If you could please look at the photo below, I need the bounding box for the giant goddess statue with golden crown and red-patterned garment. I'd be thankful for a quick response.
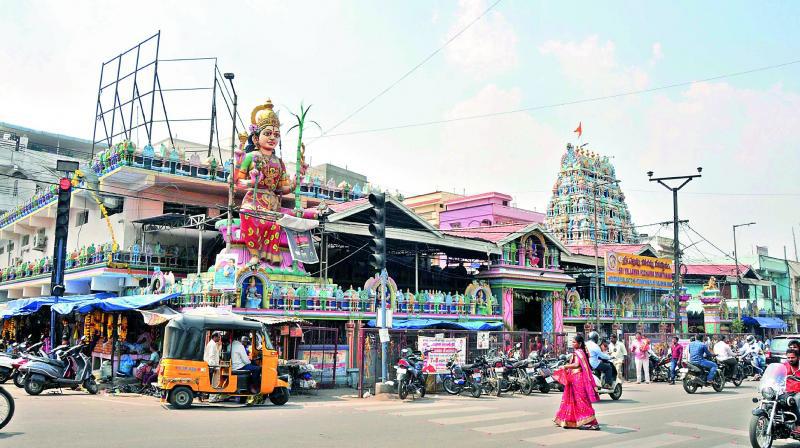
[235,99,306,266]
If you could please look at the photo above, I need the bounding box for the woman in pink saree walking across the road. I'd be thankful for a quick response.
[553,335,600,430]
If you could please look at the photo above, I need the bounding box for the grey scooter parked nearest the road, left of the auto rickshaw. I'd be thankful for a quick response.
[25,344,98,395]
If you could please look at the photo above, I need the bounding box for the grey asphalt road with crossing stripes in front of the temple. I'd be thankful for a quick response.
[0,382,788,448]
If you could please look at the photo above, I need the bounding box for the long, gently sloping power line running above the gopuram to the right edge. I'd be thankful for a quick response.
[317,59,800,139]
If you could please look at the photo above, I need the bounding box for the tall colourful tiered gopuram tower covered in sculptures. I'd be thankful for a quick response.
[545,144,637,244]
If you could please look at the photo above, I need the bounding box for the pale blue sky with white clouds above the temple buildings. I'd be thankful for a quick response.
[0,0,800,263]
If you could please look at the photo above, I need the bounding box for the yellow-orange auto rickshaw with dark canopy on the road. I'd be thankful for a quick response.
[157,314,289,409]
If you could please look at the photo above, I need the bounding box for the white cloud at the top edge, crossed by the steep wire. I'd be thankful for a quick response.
[445,0,519,79]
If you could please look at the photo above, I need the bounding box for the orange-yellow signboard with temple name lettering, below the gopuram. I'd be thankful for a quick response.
[605,252,673,290]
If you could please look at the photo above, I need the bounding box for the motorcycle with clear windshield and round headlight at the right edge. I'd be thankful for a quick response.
[749,363,800,448]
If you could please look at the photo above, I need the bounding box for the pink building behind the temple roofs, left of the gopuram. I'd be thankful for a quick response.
[439,192,545,230]
